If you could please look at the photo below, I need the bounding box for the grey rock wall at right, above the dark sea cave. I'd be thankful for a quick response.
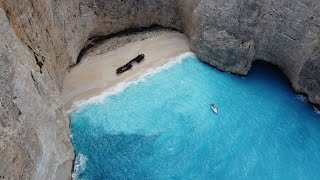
[192,0,320,105]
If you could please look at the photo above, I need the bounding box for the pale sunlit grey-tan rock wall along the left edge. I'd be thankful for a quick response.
[0,1,74,179]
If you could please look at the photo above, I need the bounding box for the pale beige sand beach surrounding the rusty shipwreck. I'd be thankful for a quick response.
[61,31,190,110]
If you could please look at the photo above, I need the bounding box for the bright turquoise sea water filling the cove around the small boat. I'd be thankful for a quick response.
[70,56,320,179]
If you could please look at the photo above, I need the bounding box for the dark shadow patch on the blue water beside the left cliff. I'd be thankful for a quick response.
[74,132,157,179]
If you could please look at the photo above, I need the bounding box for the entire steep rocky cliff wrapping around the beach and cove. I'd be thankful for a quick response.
[0,0,320,179]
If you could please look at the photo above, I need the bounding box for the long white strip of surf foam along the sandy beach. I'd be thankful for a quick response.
[68,52,196,113]
